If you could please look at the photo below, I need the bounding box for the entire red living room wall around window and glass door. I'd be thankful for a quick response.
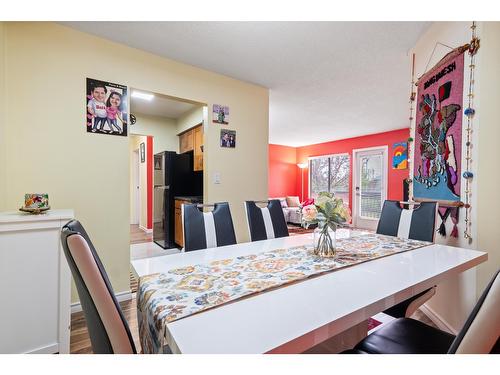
[269,128,410,206]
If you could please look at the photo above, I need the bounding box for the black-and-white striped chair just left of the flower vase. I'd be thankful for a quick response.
[245,199,288,241]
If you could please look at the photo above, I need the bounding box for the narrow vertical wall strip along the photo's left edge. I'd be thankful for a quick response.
[0,22,7,211]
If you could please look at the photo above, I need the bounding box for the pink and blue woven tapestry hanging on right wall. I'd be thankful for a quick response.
[413,51,464,202]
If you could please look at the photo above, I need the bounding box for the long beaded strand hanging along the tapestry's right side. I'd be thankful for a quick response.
[462,22,479,242]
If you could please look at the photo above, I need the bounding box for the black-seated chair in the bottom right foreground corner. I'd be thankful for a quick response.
[344,271,500,354]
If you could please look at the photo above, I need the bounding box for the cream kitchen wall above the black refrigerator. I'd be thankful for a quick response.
[129,112,179,154]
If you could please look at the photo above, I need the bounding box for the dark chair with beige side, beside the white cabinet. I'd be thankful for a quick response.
[61,220,137,354]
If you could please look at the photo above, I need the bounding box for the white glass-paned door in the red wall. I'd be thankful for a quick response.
[353,147,387,230]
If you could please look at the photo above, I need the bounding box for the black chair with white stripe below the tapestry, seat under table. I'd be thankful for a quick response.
[377,200,437,318]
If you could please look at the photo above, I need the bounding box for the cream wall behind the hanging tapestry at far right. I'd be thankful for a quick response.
[410,22,500,332]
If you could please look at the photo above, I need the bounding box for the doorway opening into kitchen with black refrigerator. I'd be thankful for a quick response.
[129,88,208,259]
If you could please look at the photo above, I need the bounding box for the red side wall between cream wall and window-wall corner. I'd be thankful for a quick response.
[268,145,300,198]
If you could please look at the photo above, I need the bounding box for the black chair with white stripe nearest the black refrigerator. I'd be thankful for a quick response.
[182,202,236,251]
